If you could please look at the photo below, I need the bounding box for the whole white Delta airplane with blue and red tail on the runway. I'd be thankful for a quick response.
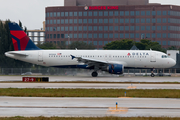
[5,23,176,77]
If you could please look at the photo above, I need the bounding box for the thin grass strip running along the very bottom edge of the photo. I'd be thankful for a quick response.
[0,116,180,120]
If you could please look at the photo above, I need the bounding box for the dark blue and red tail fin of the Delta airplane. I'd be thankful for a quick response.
[9,23,40,51]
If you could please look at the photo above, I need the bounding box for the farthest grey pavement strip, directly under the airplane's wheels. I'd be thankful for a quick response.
[0,76,180,82]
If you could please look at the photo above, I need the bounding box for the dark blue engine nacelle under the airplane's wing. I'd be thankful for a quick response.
[107,64,124,74]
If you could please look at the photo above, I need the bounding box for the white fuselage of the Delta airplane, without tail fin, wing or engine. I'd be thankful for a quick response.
[5,50,176,68]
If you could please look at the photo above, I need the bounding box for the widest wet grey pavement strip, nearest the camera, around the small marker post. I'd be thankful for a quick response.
[0,97,180,117]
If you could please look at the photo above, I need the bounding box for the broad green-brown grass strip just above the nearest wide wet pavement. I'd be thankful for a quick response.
[0,88,180,98]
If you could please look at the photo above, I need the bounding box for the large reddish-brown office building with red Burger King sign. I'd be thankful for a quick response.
[45,0,180,49]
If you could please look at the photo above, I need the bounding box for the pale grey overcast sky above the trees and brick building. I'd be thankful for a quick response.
[0,0,180,30]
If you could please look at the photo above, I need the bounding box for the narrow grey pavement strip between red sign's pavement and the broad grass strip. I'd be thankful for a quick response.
[0,83,180,89]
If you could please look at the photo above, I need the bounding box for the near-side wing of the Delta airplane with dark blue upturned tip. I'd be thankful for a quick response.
[71,55,127,67]
